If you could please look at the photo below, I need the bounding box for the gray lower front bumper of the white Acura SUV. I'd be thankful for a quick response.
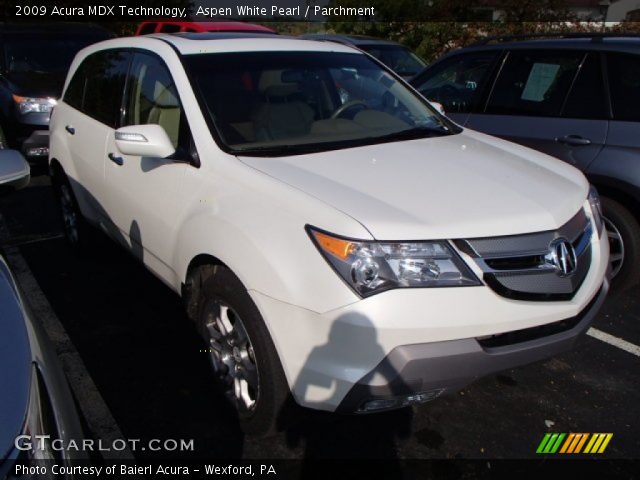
[337,280,609,413]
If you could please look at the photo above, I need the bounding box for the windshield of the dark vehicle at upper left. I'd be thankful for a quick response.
[3,36,105,73]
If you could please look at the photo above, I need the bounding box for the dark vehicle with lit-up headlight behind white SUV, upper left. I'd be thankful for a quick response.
[0,23,113,159]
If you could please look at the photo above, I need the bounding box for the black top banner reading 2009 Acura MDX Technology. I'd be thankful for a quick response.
[0,0,640,24]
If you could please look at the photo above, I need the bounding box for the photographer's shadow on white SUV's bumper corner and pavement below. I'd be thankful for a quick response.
[279,313,413,478]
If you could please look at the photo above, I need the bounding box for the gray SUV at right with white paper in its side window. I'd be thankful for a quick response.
[411,35,640,290]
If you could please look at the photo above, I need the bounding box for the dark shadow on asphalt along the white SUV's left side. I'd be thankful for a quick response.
[12,175,244,460]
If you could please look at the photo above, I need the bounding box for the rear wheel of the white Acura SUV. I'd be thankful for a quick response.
[52,172,96,253]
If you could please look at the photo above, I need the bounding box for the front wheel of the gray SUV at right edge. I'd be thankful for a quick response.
[601,197,640,293]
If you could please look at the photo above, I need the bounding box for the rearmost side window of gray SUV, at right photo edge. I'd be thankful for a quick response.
[607,53,640,122]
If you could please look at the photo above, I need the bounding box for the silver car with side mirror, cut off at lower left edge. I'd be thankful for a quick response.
[0,149,86,479]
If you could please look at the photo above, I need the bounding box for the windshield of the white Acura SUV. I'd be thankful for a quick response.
[186,52,456,156]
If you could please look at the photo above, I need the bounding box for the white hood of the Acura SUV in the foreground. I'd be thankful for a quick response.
[240,130,589,240]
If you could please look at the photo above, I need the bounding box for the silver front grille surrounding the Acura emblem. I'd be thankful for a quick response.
[455,209,593,301]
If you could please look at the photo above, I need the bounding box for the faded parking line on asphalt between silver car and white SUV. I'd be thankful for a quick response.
[0,214,134,460]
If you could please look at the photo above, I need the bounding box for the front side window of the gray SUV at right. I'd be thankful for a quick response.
[412,52,497,113]
